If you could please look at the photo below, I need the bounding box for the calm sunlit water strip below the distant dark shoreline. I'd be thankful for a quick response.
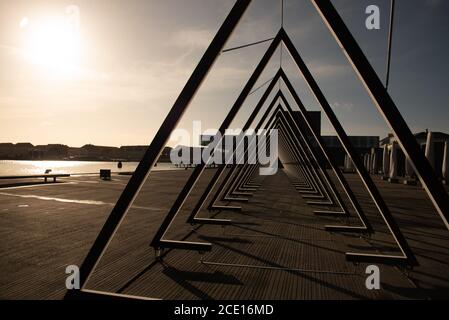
[0,160,179,176]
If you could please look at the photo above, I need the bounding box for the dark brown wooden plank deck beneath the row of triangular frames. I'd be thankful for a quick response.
[0,169,449,299]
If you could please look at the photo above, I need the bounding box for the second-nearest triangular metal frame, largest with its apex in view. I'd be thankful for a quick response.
[151,27,417,266]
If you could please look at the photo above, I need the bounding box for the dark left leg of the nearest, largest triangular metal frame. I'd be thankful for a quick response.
[65,0,251,299]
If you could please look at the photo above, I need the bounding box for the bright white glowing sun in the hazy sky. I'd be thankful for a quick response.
[25,18,83,72]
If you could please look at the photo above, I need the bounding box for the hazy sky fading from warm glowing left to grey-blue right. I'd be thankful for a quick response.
[0,0,449,147]
